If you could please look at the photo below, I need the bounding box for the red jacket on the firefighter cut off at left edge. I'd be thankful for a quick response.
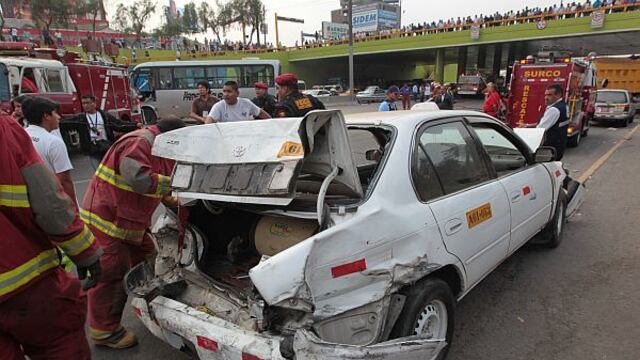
[0,116,101,303]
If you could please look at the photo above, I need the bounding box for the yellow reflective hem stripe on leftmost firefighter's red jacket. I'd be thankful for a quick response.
[0,249,60,296]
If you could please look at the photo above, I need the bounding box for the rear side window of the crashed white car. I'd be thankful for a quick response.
[414,121,491,201]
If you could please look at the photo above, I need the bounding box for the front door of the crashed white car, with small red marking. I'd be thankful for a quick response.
[469,118,553,253]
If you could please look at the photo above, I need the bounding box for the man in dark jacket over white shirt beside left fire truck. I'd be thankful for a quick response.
[74,94,140,161]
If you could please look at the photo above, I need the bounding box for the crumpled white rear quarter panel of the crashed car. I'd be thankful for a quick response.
[250,126,464,319]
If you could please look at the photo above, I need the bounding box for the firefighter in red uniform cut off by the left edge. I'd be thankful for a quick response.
[0,116,101,360]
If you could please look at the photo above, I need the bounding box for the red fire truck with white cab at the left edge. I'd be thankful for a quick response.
[0,42,143,151]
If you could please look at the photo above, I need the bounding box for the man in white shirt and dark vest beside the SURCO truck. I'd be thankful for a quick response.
[537,84,569,161]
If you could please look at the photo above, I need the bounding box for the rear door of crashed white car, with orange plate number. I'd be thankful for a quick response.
[412,118,510,286]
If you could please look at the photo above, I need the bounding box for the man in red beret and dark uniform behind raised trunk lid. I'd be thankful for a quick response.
[275,73,325,117]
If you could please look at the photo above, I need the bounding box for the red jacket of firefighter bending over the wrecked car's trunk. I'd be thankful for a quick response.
[80,126,174,244]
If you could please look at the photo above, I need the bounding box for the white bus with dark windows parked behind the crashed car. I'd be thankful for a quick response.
[131,60,280,123]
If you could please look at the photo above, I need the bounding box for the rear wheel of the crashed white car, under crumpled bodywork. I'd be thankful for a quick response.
[390,277,455,360]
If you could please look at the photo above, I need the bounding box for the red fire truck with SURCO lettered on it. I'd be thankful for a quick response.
[506,51,596,147]
